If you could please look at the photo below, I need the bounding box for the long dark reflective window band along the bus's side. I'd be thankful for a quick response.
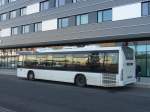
[19,51,119,73]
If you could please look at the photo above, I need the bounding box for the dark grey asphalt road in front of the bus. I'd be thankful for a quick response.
[0,75,150,112]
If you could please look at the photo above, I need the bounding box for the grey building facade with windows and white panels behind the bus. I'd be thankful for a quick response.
[0,0,150,77]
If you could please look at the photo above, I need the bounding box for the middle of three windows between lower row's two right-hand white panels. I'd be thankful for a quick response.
[76,14,88,25]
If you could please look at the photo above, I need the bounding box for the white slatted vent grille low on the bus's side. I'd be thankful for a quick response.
[102,73,116,87]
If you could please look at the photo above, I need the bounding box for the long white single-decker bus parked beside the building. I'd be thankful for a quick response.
[17,47,136,87]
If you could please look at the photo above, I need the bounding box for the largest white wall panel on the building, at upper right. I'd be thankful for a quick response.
[112,3,141,21]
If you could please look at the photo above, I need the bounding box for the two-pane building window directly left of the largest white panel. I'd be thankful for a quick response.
[98,9,112,23]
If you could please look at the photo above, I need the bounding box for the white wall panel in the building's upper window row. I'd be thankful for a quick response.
[27,3,40,15]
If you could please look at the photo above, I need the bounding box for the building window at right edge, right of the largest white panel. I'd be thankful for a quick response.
[142,2,150,16]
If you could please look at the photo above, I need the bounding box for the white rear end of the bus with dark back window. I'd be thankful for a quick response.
[120,47,136,85]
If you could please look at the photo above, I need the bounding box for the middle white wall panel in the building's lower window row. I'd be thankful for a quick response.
[42,19,57,31]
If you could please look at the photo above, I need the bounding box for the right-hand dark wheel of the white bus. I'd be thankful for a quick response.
[75,74,86,87]
